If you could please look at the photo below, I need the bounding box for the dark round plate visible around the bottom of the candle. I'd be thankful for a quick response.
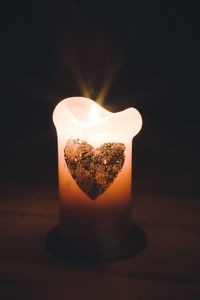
[45,223,146,262]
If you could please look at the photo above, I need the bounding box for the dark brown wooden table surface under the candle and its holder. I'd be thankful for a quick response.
[0,184,200,300]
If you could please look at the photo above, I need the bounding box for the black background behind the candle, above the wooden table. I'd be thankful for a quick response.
[0,0,200,195]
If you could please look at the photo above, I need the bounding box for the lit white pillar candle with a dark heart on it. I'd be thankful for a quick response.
[53,97,142,257]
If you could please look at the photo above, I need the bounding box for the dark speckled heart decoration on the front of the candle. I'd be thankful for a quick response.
[64,139,125,200]
